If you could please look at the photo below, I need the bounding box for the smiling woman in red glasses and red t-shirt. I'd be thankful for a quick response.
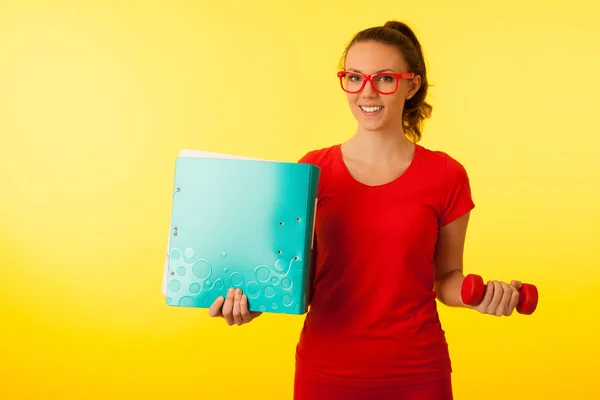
[210,21,521,400]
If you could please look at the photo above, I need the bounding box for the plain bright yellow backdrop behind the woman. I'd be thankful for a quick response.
[0,0,600,400]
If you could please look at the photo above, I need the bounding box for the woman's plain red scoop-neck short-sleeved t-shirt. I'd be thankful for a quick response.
[296,145,474,387]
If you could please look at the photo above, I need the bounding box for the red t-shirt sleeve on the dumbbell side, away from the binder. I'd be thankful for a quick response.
[440,156,475,227]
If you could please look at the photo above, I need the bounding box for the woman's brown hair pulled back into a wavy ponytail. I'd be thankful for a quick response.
[340,21,432,142]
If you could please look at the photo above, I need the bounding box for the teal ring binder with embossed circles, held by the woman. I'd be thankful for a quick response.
[163,151,320,314]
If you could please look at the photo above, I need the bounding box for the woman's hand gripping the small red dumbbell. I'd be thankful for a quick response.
[470,281,523,317]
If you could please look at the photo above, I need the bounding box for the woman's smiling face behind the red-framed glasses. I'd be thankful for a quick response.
[345,42,420,131]
